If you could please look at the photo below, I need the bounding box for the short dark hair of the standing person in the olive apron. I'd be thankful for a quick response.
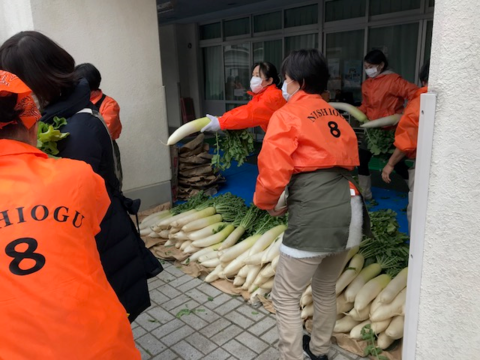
[282,49,329,95]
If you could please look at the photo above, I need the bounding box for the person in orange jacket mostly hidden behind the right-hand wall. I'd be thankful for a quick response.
[382,61,430,232]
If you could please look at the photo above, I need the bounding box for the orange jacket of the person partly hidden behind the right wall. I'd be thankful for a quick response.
[393,86,428,159]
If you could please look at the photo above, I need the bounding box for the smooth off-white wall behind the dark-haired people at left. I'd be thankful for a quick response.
[2,0,171,207]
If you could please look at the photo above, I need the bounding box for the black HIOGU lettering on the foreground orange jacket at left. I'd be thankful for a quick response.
[0,205,85,229]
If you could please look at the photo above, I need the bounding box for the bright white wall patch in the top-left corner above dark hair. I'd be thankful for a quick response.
[0,0,33,44]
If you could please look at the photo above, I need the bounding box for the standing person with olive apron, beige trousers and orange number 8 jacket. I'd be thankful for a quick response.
[254,50,368,360]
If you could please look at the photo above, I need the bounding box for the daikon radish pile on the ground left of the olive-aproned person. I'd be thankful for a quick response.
[140,194,287,303]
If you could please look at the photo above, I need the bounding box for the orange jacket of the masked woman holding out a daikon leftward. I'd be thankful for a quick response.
[218,85,286,131]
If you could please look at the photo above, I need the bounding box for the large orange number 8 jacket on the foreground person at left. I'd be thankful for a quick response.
[0,140,140,360]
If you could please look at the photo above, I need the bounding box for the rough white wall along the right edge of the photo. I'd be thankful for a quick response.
[414,0,480,360]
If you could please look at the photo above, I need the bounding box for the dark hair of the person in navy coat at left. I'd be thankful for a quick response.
[0,31,77,107]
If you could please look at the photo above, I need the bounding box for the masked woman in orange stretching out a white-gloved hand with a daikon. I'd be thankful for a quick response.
[201,61,285,132]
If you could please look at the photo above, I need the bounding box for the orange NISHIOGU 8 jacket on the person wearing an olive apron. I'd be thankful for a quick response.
[254,91,359,210]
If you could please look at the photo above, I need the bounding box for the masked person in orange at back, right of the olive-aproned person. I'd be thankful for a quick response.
[358,50,418,200]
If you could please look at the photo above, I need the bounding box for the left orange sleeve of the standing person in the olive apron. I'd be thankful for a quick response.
[253,113,298,210]
